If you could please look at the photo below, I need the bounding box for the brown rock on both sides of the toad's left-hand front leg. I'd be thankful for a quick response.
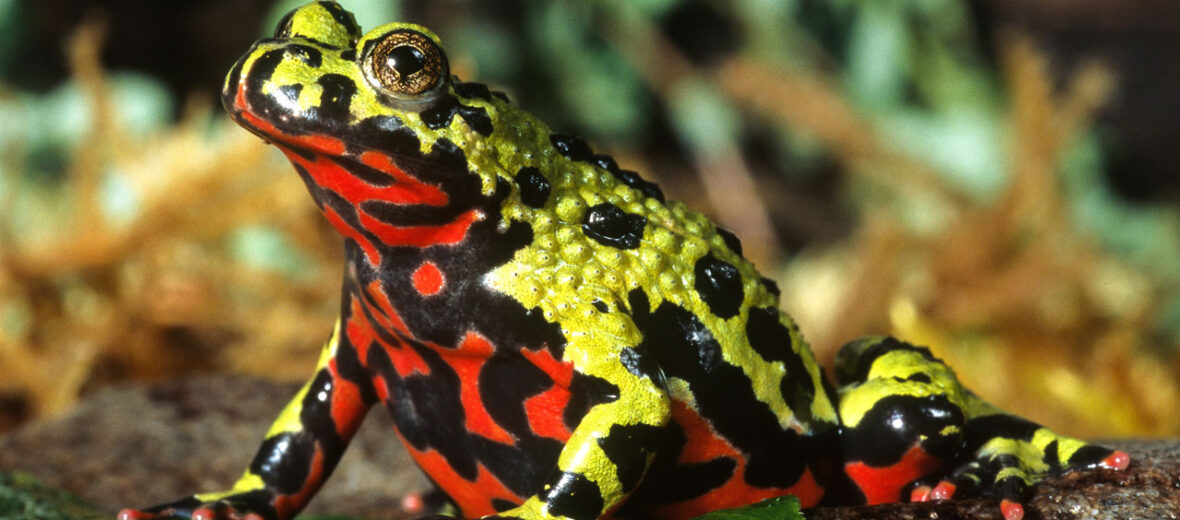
[0,375,428,519]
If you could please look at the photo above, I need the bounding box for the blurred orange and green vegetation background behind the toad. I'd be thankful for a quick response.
[0,0,1180,437]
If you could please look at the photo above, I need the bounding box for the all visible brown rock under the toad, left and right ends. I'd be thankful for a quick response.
[0,375,1180,520]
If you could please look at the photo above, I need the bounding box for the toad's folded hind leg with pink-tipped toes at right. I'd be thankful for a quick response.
[835,337,1129,520]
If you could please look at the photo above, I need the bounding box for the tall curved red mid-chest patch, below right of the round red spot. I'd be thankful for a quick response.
[445,331,516,445]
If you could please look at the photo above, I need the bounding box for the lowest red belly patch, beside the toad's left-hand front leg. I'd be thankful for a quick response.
[402,439,524,518]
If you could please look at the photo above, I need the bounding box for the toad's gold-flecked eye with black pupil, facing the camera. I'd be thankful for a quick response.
[363,29,447,99]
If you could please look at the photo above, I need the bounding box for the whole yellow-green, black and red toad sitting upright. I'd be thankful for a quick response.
[120,2,1126,520]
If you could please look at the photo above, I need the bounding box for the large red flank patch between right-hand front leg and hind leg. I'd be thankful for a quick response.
[654,401,824,519]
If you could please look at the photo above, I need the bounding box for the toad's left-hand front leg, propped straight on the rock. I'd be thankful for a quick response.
[118,323,375,520]
